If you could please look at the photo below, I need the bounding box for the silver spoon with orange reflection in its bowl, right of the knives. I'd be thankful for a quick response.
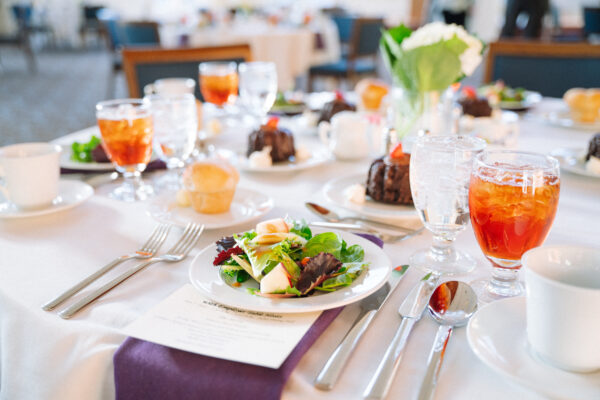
[418,281,477,400]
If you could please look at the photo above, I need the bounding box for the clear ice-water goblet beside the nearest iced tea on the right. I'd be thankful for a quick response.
[410,136,485,274]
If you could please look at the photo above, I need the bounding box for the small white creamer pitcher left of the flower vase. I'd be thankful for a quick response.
[319,111,370,160]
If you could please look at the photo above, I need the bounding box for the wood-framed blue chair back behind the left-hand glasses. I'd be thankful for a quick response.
[123,44,252,99]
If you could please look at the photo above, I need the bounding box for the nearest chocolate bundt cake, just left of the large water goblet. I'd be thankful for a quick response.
[367,154,413,205]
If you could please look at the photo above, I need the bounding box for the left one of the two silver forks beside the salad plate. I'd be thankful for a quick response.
[42,224,171,311]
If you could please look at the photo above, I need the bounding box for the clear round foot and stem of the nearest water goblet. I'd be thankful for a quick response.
[409,236,477,275]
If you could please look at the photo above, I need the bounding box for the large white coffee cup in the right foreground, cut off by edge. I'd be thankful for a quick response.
[522,246,600,372]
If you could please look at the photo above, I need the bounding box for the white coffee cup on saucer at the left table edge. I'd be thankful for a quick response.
[0,143,61,209]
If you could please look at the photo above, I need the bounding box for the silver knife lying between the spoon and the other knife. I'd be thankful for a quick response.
[364,273,440,399]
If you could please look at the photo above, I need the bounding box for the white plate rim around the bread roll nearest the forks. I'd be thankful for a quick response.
[146,187,275,230]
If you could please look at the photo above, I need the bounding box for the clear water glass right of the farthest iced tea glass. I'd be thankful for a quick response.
[239,62,277,122]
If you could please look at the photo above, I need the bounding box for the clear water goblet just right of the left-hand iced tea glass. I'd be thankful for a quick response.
[144,93,198,190]
